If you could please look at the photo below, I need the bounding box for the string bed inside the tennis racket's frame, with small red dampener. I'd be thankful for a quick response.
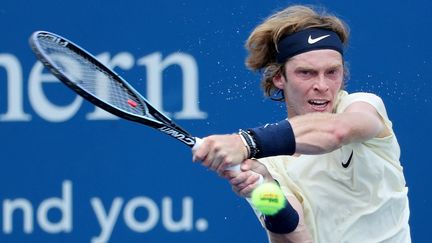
[34,38,149,116]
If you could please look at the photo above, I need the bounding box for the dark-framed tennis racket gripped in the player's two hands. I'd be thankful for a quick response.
[29,31,250,175]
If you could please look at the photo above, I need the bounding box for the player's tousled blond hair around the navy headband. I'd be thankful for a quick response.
[245,5,349,97]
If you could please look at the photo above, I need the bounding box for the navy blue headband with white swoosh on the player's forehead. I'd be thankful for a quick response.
[276,28,343,64]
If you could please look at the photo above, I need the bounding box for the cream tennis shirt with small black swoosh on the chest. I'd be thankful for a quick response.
[258,91,411,243]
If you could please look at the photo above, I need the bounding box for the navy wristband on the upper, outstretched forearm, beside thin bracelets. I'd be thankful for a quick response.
[248,120,296,159]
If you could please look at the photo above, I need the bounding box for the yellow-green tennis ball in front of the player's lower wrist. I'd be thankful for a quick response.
[252,183,286,216]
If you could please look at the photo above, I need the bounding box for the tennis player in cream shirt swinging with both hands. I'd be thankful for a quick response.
[193,5,411,243]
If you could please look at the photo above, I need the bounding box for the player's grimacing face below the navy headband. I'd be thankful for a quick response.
[273,50,344,117]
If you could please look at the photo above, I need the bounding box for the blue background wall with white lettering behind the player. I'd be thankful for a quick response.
[0,0,432,242]
